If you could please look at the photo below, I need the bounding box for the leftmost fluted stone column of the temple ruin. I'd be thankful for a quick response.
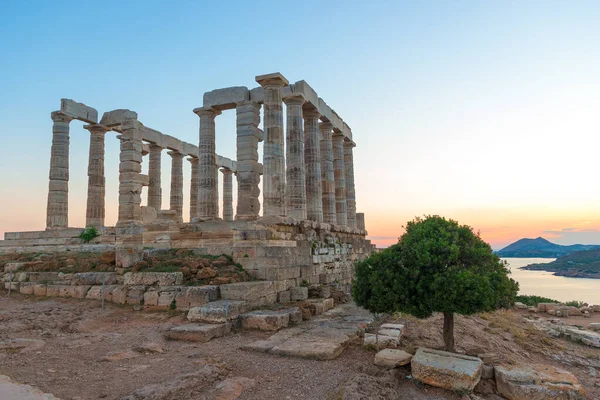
[46,111,72,229]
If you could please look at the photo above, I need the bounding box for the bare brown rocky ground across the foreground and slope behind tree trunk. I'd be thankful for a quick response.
[0,291,600,400]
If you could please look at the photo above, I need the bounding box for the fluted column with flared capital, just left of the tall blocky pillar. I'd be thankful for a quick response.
[194,107,221,220]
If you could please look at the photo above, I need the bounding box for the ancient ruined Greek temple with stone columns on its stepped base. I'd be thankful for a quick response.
[0,73,372,286]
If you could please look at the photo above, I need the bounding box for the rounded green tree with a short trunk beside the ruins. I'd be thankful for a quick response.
[352,216,519,351]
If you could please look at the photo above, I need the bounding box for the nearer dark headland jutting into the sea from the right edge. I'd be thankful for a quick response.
[521,248,600,279]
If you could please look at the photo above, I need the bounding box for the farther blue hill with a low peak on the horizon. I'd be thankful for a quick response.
[496,237,600,258]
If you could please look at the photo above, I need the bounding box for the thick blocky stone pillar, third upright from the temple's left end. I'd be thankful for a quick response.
[117,120,144,225]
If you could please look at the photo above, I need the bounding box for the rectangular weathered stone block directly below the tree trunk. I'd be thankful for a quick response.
[411,349,483,392]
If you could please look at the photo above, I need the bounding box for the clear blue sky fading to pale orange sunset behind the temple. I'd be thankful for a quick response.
[0,0,600,249]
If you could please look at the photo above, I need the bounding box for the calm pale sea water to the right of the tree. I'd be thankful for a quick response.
[503,258,600,304]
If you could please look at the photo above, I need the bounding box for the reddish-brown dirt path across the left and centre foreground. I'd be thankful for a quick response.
[0,292,457,400]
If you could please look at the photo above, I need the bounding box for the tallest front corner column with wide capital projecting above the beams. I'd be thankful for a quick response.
[256,73,289,216]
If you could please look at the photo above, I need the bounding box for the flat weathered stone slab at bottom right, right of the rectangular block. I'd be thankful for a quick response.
[494,365,586,400]
